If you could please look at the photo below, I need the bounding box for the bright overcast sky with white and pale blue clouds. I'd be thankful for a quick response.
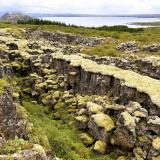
[0,0,160,14]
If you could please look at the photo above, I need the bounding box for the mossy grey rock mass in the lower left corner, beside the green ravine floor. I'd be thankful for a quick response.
[0,79,49,160]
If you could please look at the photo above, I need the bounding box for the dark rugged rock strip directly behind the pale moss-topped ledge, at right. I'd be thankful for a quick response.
[87,56,160,79]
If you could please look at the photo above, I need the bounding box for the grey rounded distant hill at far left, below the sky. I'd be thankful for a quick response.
[0,12,33,23]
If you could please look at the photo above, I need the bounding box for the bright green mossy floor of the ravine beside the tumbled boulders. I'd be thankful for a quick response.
[23,101,114,160]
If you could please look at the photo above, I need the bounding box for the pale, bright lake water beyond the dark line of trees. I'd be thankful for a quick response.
[42,17,160,28]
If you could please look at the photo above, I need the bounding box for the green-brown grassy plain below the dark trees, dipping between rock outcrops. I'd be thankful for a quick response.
[0,23,160,57]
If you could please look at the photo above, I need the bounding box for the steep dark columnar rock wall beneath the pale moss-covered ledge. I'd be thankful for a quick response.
[51,53,160,115]
